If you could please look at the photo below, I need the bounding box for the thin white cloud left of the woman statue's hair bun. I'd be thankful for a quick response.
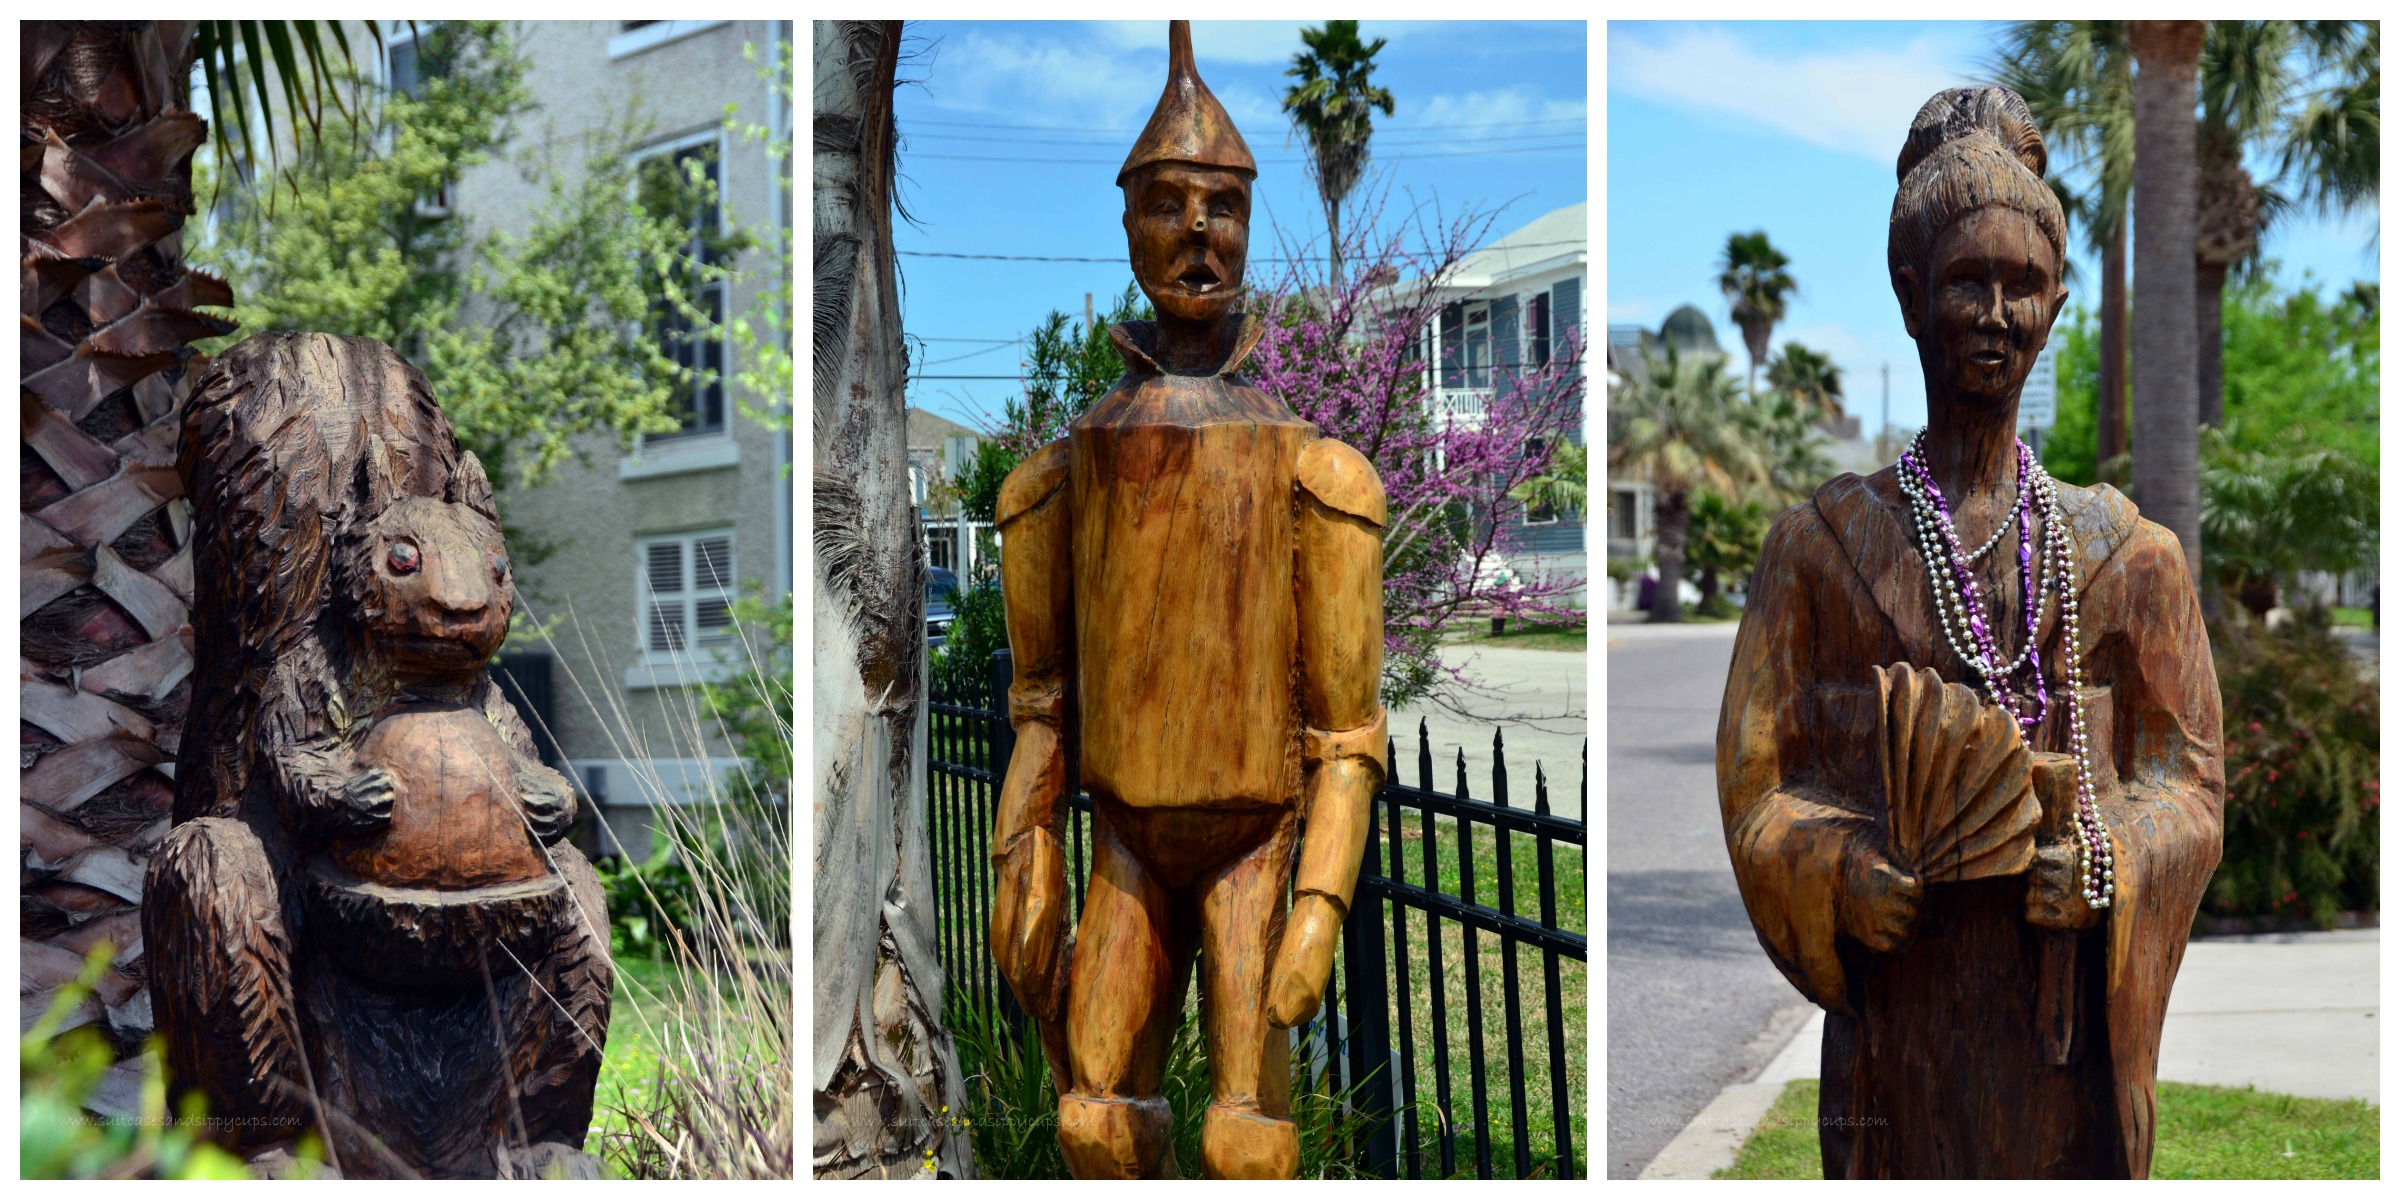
[1608,29,1966,163]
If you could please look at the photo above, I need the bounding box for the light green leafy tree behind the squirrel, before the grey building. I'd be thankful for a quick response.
[194,22,746,485]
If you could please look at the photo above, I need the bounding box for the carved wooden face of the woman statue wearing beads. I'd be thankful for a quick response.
[1891,206,2066,401]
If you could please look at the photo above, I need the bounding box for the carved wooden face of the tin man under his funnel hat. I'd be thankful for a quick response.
[1126,163,1250,322]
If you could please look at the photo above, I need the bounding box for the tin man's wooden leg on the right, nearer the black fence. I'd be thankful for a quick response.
[1198,816,1301,1178]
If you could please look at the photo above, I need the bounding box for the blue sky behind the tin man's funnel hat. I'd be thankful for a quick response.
[893,22,1591,425]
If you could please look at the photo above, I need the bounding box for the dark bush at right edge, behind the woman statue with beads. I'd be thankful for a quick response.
[2206,612,2383,929]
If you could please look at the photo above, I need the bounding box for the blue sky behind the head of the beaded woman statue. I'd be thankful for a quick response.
[1606,22,2381,430]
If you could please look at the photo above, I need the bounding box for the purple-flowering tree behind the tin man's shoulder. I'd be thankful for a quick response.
[1243,194,1584,706]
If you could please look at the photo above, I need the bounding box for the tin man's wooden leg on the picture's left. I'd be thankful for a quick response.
[1058,802,1193,1178]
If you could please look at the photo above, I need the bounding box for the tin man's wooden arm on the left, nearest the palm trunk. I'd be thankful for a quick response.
[991,439,1075,1022]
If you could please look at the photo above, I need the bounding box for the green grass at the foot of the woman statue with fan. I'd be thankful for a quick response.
[1714,1080,2383,1178]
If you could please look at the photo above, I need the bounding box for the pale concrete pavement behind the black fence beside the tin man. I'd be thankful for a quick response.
[1392,643,1591,818]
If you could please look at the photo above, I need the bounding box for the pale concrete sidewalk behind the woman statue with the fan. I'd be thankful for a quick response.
[1642,929,2383,1178]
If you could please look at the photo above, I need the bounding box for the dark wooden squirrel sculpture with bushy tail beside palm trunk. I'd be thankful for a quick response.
[142,334,612,1176]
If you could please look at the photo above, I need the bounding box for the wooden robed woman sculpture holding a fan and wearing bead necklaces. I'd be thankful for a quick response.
[1716,89,2225,1178]
